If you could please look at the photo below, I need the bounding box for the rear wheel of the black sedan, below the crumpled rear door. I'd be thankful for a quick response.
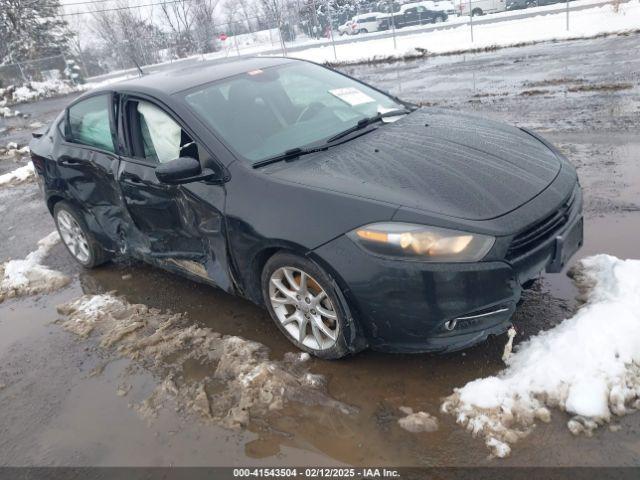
[53,201,110,269]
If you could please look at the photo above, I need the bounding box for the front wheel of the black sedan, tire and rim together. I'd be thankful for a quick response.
[261,252,363,360]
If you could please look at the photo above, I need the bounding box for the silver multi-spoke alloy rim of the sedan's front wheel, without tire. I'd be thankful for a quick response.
[269,267,340,350]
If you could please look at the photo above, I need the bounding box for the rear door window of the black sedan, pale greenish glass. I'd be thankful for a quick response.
[67,94,115,152]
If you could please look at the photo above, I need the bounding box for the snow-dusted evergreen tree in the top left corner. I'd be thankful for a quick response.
[0,0,73,64]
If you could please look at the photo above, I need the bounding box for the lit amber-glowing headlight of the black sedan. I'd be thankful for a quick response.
[347,222,495,262]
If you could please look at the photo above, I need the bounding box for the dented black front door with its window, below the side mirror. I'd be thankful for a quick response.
[118,96,231,290]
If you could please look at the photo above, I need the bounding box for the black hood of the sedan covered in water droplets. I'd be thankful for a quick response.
[270,109,561,220]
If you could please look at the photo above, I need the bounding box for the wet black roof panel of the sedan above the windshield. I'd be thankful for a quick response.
[91,57,295,95]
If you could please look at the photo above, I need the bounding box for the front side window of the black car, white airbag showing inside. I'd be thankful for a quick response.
[135,100,198,163]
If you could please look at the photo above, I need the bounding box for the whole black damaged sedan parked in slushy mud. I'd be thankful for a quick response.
[31,58,583,358]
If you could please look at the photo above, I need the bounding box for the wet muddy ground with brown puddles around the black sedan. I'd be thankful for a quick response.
[0,32,640,466]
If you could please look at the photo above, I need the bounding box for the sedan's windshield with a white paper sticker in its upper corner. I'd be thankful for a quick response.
[184,62,404,163]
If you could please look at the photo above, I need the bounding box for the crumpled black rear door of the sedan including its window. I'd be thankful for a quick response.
[50,92,123,250]
